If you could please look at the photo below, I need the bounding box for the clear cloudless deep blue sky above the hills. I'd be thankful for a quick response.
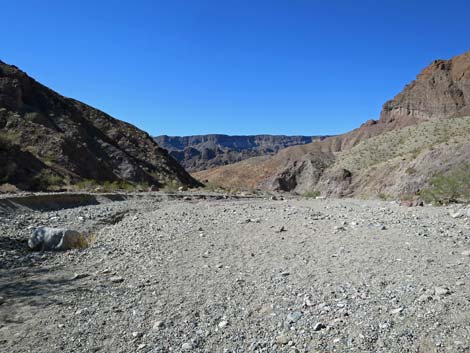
[0,0,470,135]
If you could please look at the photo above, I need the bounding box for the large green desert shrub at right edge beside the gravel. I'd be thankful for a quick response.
[421,163,470,205]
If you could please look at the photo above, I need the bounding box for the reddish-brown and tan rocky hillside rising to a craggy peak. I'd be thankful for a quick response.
[195,52,470,197]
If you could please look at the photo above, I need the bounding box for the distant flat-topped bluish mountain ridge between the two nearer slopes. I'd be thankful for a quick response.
[155,134,322,171]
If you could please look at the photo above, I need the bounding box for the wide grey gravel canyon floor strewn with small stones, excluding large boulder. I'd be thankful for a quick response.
[0,193,470,353]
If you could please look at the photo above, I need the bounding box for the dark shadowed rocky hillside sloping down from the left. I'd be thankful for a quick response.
[0,61,197,190]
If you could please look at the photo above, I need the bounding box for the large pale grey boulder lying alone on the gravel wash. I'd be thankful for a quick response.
[28,227,88,251]
